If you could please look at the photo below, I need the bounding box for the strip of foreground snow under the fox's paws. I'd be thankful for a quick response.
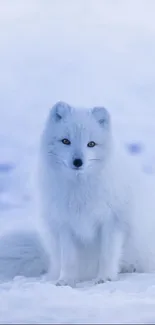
[0,274,155,324]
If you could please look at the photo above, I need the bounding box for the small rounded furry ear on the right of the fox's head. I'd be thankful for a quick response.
[92,107,110,127]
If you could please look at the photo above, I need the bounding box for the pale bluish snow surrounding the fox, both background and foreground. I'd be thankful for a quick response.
[0,0,155,324]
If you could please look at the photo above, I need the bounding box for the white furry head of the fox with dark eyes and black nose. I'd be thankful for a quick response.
[41,102,111,175]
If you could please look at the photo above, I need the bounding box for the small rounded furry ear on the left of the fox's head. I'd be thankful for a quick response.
[51,101,71,121]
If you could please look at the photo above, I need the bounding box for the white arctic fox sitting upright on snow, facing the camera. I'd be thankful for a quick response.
[36,102,131,286]
